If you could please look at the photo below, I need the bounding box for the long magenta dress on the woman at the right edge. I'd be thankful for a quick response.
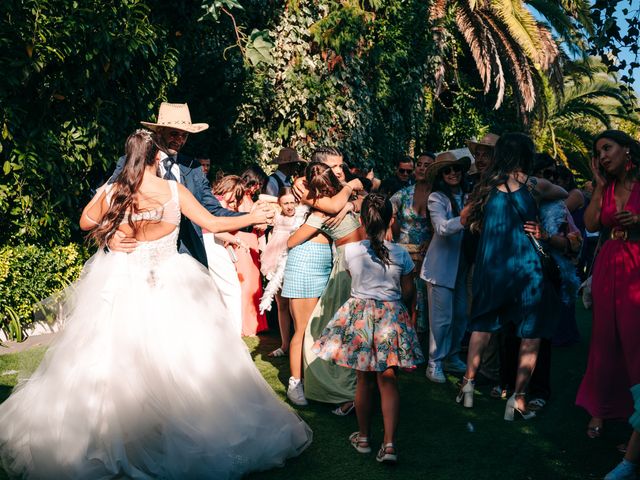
[576,182,640,419]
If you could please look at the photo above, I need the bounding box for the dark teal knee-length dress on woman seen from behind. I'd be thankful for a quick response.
[468,186,557,338]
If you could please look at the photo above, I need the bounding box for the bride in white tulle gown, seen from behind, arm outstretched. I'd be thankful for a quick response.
[0,130,312,479]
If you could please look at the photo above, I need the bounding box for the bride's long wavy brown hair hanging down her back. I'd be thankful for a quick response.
[87,129,159,247]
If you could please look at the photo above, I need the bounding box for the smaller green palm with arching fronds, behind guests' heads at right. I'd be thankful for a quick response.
[532,58,640,175]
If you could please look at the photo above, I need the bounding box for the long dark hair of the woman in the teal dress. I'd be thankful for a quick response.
[467,133,536,233]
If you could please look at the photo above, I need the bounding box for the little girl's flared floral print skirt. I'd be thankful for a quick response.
[313,297,424,372]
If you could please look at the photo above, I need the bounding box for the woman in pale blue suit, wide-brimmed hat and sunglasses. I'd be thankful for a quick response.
[420,152,471,383]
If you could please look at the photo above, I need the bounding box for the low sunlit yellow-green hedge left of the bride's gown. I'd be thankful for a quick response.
[0,243,88,341]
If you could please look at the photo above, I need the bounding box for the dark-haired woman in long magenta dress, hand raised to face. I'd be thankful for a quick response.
[576,130,640,438]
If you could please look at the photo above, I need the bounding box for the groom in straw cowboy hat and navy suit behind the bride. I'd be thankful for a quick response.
[109,102,245,267]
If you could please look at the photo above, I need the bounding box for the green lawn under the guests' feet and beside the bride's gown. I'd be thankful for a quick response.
[0,306,630,480]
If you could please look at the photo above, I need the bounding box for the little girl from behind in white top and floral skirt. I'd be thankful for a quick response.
[313,193,424,462]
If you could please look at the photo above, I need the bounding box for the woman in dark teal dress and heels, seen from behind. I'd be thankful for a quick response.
[456,133,566,420]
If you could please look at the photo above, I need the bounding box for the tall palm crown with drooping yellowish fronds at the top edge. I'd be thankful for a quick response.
[430,0,591,116]
